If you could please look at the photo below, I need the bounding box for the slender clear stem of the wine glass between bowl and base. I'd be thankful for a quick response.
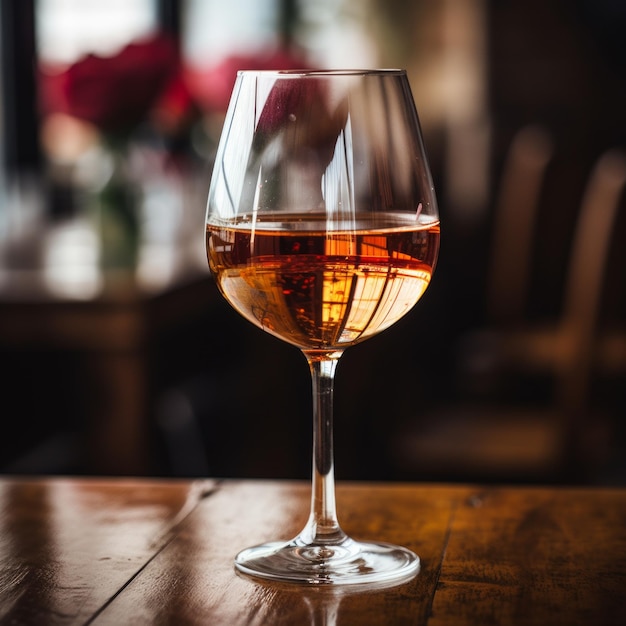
[299,352,347,545]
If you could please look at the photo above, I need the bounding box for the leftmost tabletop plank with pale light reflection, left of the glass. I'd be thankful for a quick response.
[0,479,214,626]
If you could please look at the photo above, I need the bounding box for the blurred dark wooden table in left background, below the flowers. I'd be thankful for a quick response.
[0,258,214,475]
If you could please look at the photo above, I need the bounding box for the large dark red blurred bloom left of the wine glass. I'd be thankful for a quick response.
[41,35,179,133]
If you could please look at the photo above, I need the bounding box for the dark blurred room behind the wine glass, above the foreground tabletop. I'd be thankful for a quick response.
[0,0,626,485]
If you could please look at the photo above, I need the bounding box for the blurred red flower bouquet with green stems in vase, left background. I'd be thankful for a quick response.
[40,35,196,269]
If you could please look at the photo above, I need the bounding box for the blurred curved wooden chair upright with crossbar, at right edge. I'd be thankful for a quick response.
[498,150,626,466]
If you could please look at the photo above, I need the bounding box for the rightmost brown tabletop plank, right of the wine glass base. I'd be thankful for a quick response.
[429,488,626,626]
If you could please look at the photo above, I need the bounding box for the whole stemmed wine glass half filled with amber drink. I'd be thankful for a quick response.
[206,70,439,585]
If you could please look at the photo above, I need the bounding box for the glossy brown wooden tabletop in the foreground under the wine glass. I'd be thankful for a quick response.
[0,477,626,626]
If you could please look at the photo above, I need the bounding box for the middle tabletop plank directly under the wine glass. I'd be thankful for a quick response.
[94,481,470,626]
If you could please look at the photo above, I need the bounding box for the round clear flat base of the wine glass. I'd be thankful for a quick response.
[235,538,420,585]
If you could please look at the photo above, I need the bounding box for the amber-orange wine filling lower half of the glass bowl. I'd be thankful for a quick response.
[207,214,439,351]
